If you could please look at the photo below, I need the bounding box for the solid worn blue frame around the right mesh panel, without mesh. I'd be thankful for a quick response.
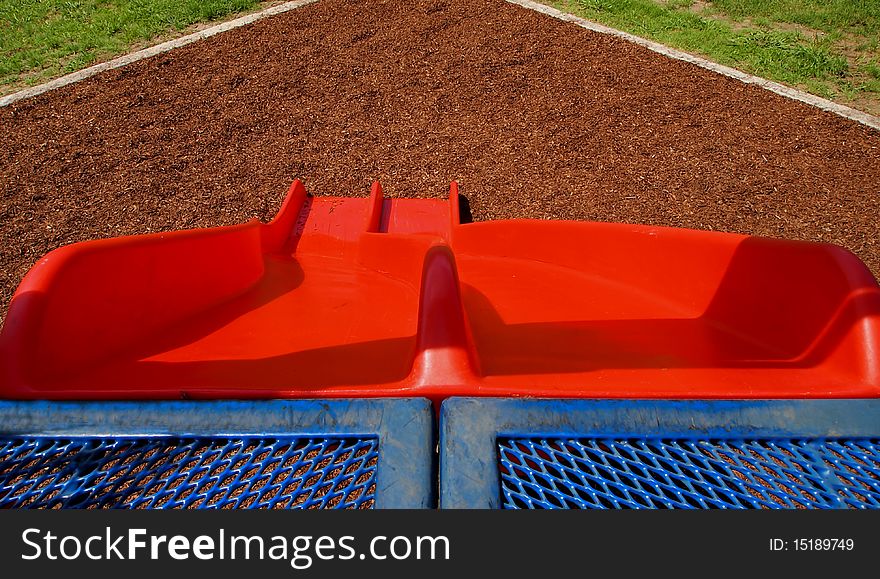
[440,398,880,508]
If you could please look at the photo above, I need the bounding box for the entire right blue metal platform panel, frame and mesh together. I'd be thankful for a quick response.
[440,398,880,508]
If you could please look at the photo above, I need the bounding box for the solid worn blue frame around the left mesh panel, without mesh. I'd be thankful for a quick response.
[0,398,436,508]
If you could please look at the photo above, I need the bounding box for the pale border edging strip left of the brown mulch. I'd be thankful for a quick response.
[0,0,317,107]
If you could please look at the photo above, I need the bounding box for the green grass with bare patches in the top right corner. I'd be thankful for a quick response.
[544,0,880,114]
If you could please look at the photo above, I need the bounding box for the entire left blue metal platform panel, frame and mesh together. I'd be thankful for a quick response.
[0,399,434,508]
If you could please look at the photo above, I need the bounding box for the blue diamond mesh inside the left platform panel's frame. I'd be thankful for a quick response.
[0,436,378,509]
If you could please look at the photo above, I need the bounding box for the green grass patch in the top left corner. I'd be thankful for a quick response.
[0,0,259,92]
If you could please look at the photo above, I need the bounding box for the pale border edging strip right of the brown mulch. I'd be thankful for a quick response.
[506,0,880,130]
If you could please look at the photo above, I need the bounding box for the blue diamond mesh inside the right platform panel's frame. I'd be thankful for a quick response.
[498,438,880,509]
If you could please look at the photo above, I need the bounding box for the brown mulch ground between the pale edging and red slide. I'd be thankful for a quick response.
[0,0,880,326]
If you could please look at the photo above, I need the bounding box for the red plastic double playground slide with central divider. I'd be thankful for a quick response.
[0,182,880,400]
